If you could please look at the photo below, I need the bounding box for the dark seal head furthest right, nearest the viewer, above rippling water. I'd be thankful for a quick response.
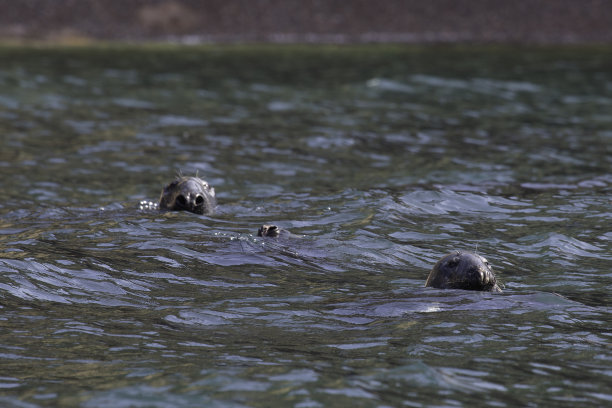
[425,251,501,292]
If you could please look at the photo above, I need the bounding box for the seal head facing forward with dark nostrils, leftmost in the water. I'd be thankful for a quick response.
[159,176,217,215]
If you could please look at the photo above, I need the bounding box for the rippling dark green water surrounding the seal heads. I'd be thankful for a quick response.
[0,47,612,408]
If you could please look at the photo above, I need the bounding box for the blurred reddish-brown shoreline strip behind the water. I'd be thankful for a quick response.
[0,0,612,44]
